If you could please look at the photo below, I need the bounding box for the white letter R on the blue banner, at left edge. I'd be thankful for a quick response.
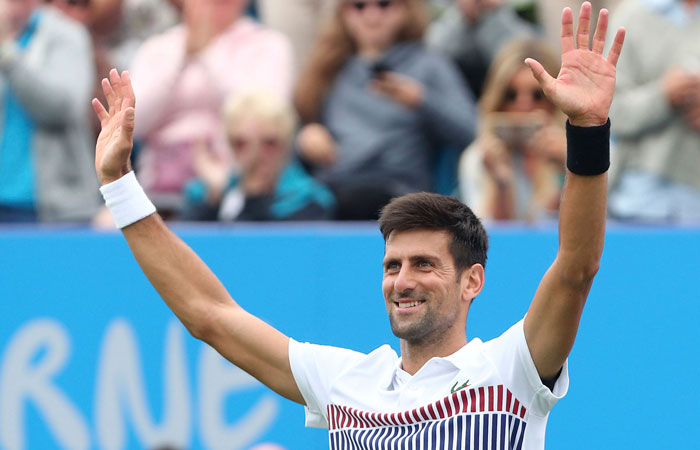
[0,319,90,450]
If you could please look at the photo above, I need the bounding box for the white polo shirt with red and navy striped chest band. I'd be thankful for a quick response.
[289,320,569,450]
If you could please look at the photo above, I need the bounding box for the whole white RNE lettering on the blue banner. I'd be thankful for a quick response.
[0,319,279,450]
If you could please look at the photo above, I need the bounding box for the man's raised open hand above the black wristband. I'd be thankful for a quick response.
[525,2,625,126]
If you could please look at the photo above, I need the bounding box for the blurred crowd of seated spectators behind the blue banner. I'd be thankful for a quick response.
[0,0,700,226]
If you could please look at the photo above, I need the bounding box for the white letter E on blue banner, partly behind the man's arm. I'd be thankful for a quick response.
[199,346,279,450]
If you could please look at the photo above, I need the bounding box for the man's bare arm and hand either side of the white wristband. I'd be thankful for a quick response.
[93,70,304,404]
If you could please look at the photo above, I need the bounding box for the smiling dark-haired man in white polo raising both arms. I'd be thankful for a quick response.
[93,2,624,449]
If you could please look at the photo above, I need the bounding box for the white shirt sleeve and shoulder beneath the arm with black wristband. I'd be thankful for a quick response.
[485,319,569,416]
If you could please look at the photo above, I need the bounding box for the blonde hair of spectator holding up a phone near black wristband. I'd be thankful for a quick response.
[479,38,561,115]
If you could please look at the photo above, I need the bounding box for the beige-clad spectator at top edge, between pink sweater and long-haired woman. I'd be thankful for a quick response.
[258,0,339,73]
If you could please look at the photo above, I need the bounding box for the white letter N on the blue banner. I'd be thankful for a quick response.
[95,320,191,450]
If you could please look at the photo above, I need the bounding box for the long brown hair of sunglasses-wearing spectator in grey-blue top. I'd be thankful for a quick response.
[294,0,430,122]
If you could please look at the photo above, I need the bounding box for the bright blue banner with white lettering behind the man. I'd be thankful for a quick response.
[0,224,700,450]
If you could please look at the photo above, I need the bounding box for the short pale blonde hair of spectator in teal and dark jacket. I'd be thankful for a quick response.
[223,89,298,141]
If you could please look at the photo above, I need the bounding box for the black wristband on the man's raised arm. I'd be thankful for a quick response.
[566,119,610,176]
